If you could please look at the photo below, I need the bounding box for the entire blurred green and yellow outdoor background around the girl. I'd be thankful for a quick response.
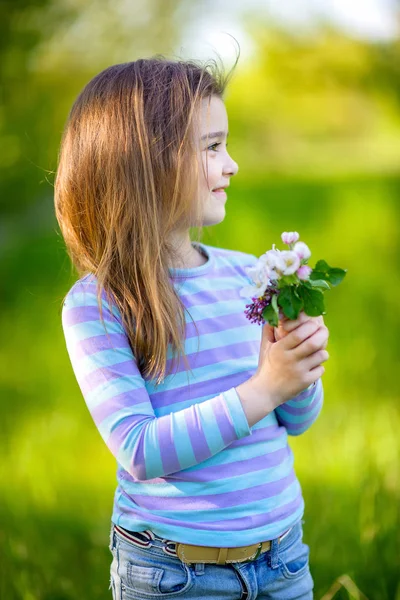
[0,0,400,600]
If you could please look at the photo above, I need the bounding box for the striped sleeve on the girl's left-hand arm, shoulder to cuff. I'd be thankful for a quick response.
[62,282,251,481]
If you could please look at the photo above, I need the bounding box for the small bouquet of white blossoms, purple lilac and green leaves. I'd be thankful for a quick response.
[240,231,347,327]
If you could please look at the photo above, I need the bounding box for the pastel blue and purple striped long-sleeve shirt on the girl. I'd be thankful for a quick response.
[62,242,323,547]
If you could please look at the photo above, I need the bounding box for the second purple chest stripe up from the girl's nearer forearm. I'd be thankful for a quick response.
[167,341,260,373]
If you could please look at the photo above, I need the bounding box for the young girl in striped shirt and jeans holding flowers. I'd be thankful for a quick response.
[55,56,328,600]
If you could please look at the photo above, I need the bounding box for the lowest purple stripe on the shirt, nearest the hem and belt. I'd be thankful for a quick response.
[118,490,303,532]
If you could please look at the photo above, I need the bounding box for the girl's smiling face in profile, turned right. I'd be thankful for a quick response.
[197,96,239,227]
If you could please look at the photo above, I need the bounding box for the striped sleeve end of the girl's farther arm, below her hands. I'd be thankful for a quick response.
[275,379,324,435]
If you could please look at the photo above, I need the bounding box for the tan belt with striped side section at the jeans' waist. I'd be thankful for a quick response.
[114,525,290,565]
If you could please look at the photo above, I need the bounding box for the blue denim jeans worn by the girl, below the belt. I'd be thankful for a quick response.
[109,521,314,600]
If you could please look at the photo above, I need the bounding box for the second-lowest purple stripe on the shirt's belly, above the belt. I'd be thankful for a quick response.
[131,469,296,512]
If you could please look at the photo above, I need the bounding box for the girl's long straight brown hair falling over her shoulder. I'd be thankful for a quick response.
[55,55,238,384]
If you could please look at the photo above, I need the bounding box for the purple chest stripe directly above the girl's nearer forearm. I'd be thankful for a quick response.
[151,371,254,409]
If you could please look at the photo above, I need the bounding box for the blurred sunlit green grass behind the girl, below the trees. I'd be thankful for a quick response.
[0,172,400,600]
